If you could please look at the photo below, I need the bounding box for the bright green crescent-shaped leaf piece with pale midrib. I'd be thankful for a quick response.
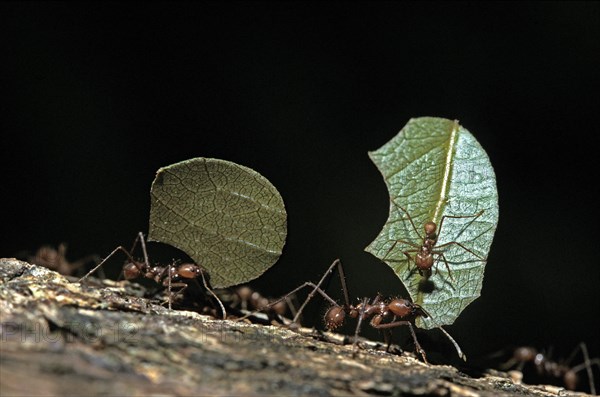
[366,117,498,328]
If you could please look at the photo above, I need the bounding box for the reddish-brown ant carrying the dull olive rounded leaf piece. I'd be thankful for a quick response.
[79,232,227,319]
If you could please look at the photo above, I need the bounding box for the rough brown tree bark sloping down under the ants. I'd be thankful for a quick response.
[0,259,583,396]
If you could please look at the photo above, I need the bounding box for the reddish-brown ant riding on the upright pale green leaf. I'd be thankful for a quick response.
[383,202,486,281]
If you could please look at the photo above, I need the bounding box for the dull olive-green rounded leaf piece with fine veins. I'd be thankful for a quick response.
[148,158,287,288]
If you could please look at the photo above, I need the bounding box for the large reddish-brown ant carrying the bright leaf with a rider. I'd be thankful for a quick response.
[240,259,466,363]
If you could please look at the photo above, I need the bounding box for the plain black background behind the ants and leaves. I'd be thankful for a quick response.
[0,2,600,376]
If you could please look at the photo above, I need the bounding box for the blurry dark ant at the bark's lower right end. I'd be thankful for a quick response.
[502,343,600,395]
